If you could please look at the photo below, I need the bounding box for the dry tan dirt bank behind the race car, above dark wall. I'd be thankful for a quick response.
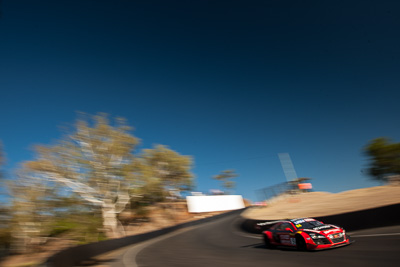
[242,185,400,220]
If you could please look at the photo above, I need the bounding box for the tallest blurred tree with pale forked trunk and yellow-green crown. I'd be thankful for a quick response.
[23,114,138,237]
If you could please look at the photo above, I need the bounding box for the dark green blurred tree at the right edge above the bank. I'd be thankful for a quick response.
[364,137,400,182]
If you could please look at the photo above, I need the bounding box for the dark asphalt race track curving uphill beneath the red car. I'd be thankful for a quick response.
[112,213,400,267]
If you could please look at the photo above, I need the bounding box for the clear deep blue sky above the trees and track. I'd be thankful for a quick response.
[0,0,400,200]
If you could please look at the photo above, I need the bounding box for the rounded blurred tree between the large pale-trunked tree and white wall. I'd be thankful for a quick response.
[136,145,193,201]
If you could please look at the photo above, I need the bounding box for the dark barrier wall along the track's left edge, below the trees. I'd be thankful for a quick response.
[43,209,243,267]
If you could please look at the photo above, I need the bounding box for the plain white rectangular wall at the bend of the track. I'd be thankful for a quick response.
[186,195,245,213]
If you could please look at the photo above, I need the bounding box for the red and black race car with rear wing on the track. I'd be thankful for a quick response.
[262,218,350,250]
